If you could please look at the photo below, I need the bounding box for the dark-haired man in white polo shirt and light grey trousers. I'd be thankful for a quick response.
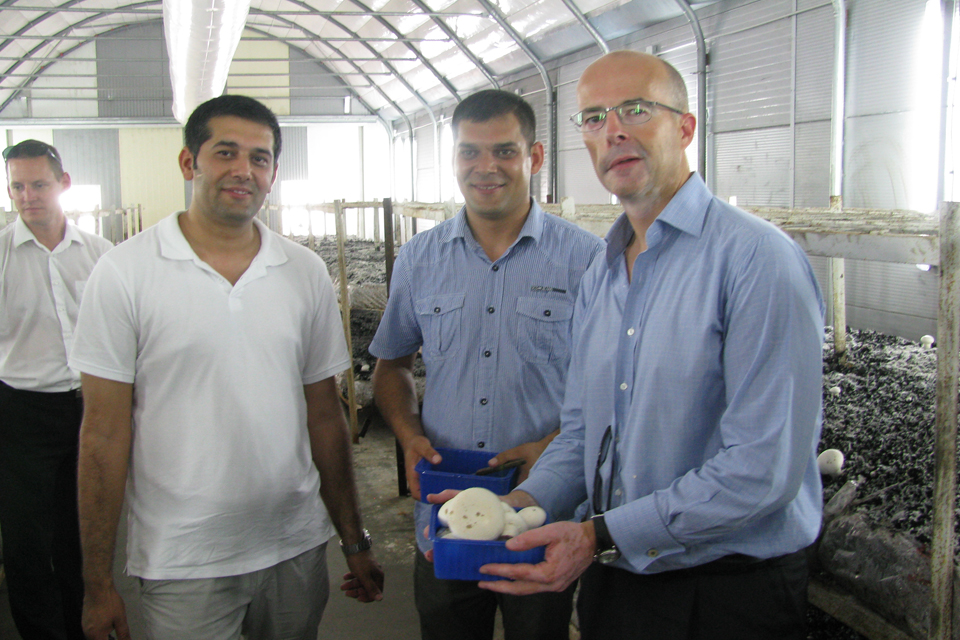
[71,95,383,640]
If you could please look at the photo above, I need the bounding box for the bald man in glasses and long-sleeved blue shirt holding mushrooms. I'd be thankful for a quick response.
[480,51,823,640]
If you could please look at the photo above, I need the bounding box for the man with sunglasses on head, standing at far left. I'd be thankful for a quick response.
[0,140,113,640]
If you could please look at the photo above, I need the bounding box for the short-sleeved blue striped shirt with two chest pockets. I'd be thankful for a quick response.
[370,202,603,550]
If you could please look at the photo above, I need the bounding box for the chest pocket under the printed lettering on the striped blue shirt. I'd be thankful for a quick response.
[517,298,573,364]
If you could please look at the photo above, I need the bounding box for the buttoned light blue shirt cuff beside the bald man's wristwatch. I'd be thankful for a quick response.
[603,496,684,573]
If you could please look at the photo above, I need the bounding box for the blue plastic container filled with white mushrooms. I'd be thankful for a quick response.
[430,504,547,580]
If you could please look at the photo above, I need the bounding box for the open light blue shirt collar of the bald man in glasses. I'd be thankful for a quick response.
[606,172,713,264]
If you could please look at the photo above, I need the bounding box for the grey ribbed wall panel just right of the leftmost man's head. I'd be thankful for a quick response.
[53,129,121,209]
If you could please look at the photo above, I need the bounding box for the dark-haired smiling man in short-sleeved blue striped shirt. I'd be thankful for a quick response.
[370,90,603,640]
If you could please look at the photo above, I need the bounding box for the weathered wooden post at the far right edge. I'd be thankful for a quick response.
[930,202,960,640]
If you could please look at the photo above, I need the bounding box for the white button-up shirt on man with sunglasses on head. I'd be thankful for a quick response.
[0,217,113,392]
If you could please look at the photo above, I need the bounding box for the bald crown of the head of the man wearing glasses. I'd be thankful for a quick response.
[577,50,690,113]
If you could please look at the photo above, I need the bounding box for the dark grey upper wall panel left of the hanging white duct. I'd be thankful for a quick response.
[97,22,173,118]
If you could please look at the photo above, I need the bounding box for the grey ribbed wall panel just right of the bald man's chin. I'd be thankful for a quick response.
[715,127,791,207]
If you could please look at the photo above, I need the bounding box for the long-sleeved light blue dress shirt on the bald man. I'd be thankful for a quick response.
[520,174,824,573]
